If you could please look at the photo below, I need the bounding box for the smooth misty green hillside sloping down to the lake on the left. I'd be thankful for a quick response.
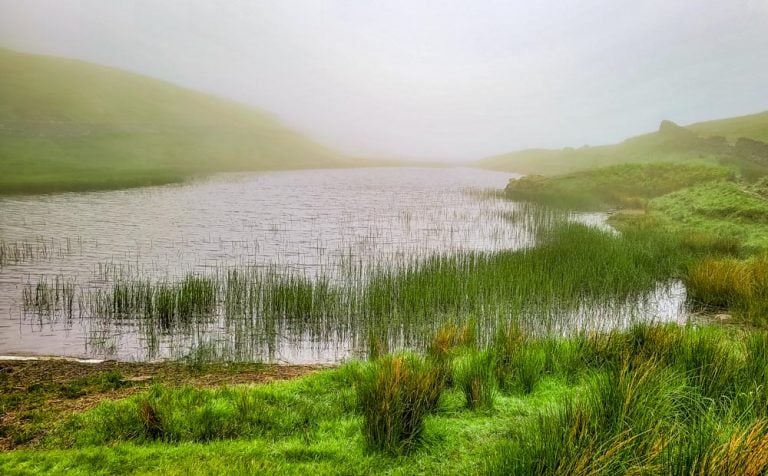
[0,49,352,193]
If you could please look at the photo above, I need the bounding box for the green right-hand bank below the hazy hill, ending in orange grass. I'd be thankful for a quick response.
[505,158,768,325]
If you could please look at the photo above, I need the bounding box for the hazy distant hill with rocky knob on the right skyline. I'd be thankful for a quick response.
[475,112,768,175]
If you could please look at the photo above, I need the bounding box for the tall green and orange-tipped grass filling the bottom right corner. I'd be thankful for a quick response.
[487,325,768,475]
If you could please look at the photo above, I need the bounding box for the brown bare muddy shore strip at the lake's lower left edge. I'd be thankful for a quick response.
[0,358,321,451]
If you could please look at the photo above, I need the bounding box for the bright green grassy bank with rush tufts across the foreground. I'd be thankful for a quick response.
[0,326,768,474]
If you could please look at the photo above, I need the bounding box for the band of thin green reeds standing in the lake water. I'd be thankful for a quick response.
[22,218,696,360]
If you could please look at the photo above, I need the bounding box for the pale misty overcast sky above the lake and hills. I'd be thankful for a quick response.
[0,0,768,160]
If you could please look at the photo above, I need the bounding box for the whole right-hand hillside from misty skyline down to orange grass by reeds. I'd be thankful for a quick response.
[492,113,768,325]
